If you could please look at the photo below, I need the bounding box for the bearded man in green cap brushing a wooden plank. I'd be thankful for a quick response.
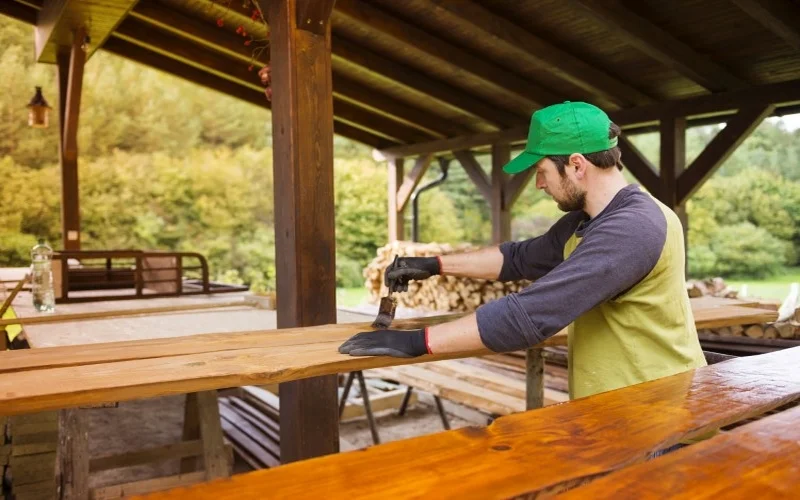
[339,102,706,399]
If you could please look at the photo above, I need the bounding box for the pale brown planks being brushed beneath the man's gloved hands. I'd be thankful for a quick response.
[0,317,566,415]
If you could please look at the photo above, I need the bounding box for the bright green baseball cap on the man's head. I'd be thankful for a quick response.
[503,101,617,174]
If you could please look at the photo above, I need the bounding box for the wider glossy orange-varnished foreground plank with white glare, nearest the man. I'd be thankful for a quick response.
[134,348,800,500]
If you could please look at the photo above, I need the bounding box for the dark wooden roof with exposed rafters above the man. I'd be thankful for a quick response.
[6,0,800,153]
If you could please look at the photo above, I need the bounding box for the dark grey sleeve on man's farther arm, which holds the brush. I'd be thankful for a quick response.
[498,212,584,281]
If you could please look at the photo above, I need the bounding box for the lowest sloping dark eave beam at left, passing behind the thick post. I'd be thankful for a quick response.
[103,35,396,147]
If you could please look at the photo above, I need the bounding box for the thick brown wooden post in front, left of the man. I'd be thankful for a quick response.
[268,0,339,463]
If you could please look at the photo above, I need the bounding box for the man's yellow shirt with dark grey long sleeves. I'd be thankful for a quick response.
[476,184,706,399]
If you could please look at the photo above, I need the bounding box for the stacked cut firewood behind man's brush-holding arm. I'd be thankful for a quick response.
[364,241,530,312]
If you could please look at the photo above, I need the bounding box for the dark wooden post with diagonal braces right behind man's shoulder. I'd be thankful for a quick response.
[659,116,689,272]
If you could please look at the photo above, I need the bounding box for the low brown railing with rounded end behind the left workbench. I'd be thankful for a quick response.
[53,250,247,303]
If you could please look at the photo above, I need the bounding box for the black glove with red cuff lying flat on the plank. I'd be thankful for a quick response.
[339,328,428,358]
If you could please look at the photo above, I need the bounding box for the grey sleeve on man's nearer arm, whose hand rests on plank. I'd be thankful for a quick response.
[476,206,667,352]
